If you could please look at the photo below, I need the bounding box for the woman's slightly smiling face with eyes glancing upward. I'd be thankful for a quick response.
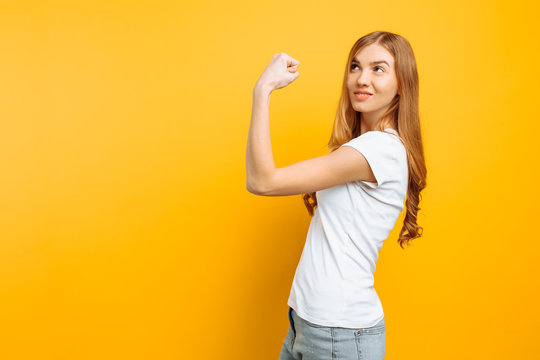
[347,44,398,119]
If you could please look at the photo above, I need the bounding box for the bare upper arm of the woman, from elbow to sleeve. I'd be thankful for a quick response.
[259,146,376,196]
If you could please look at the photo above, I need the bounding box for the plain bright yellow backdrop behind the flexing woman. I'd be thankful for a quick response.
[0,0,540,360]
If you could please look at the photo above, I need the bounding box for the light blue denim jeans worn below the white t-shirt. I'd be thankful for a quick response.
[279,307,386,360]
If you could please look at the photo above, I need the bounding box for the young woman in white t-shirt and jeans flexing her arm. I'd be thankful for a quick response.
[246,31,426,360]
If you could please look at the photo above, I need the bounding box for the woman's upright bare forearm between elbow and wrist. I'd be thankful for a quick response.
[246,85,276,191]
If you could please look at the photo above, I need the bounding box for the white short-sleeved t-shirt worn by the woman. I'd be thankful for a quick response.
[287,128,409,328]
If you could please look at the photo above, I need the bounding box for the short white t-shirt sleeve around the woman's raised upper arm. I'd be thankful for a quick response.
[341,131,399,187]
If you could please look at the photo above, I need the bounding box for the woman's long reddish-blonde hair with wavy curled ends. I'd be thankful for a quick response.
[303,31,427,249]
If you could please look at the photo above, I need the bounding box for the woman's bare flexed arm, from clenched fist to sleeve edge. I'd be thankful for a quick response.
[246,54,376,196]
